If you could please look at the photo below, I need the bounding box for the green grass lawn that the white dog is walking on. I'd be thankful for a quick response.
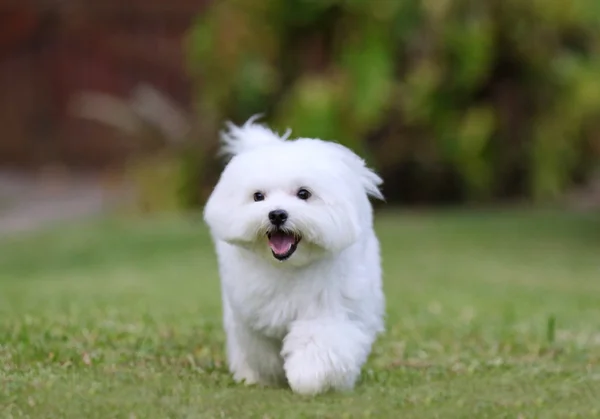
[0,212,600,419]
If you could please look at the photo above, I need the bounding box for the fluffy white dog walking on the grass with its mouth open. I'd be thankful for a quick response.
[204,118,385,394]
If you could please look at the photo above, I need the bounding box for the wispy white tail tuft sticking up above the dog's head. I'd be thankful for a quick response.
[220,115,291,158]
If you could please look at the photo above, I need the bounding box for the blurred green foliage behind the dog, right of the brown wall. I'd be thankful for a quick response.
[187,0,600,205]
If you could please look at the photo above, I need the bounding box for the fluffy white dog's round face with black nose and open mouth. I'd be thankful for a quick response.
[204,139,378,266]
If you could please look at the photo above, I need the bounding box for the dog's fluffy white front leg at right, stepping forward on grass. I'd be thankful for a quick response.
[281,319,373,395]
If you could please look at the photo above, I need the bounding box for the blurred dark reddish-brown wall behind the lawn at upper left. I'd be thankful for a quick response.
[0,0,206,167]
